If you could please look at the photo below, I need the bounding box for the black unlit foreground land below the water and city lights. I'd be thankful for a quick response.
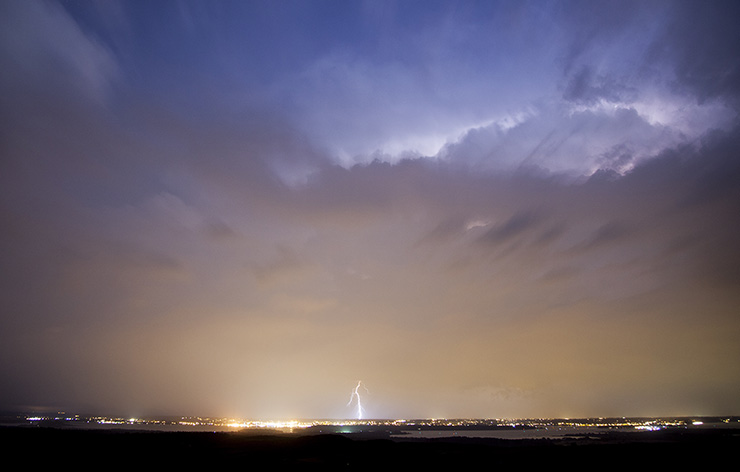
[0,427,740,470]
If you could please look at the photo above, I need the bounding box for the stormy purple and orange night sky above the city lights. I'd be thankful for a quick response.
[0,0,740,419]
